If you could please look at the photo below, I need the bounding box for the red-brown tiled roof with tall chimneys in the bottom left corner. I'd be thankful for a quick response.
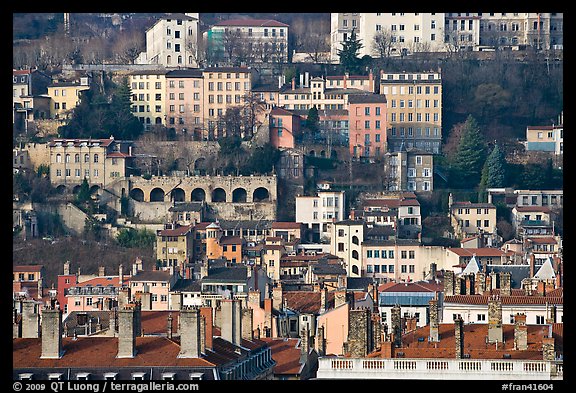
[12,336,214,368]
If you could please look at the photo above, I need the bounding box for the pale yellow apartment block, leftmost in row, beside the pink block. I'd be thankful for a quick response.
[128,70,167,130]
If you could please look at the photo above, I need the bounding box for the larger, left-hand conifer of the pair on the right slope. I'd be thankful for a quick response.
[451,115,486,188]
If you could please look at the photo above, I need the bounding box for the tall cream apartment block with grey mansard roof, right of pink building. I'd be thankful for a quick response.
[380,71,442,154]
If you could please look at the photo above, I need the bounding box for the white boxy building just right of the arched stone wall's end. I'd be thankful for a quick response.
[296,191,345,241]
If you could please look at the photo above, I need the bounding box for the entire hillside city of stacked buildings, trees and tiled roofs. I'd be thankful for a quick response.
[12,13,564,382]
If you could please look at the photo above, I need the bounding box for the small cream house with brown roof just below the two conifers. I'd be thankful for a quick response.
[449,194,496,237]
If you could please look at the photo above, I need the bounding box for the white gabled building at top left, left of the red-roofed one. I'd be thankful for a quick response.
[135,13,200,68]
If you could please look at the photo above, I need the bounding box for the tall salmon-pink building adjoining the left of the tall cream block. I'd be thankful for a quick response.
[348,94,387,157]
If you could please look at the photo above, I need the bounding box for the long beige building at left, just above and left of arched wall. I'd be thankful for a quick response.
[48,137,133,189]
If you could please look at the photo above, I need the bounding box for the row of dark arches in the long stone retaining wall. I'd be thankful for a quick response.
[130,187,270,203]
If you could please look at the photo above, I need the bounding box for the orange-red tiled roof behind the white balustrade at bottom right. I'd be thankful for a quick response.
[369,323,563,360]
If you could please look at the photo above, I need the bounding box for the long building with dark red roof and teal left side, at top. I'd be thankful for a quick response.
[205,19,289,65]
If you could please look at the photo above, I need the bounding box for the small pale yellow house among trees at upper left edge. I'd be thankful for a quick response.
[47,77,90,119]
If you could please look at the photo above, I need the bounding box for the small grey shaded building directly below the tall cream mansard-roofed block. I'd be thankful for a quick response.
[384,148,434,192]
